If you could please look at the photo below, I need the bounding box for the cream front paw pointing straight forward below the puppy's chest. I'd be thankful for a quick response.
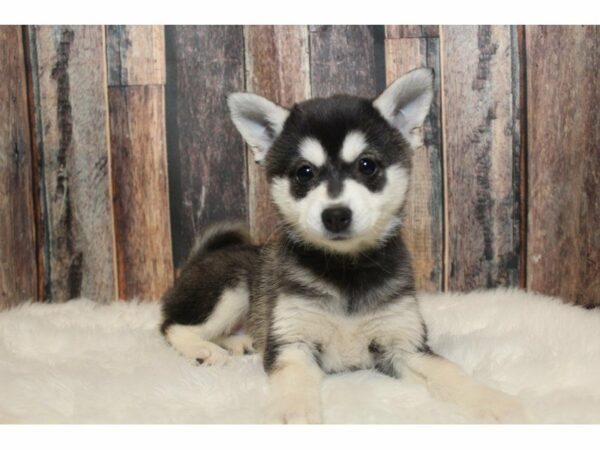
[266,395,323,424]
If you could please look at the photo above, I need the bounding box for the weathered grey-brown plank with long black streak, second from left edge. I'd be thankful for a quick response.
[30,26,117,301]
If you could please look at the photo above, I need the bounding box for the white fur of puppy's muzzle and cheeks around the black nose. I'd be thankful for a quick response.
[271,165,409,253]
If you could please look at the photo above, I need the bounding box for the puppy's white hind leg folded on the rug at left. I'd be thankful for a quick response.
[164,283,249,365]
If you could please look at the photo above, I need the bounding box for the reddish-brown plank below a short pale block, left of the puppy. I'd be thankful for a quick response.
[108,85,173,299]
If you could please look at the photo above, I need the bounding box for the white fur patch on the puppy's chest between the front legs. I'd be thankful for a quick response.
[273,296,423,372]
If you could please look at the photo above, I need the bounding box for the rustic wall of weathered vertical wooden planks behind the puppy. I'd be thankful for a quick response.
[0,26,600,306]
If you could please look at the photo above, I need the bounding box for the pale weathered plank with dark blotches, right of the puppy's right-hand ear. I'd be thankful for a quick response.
[440,26,520,290]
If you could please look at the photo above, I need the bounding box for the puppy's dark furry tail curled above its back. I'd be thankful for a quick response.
[190,222,252,258]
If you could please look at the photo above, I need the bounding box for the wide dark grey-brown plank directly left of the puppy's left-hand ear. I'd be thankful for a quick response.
[166,26,247,266]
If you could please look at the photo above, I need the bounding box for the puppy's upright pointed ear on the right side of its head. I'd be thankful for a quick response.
[373,68,433,148]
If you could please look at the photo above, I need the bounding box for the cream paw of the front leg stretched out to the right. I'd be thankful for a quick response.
[469,388,529,423]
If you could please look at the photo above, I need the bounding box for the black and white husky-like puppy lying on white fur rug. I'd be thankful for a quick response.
[161,69,521,423]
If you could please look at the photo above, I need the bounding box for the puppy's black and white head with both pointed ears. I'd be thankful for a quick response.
[228,69,433,253]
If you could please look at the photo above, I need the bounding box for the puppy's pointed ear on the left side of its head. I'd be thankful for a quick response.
[227,92,290,163]
